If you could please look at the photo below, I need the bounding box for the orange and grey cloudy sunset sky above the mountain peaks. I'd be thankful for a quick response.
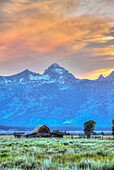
[0,0,114,79]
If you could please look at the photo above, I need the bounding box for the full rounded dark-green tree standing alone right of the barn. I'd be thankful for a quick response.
[84,120,96,138]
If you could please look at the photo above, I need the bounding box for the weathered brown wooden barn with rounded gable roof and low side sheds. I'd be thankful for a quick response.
[22,125,63,138]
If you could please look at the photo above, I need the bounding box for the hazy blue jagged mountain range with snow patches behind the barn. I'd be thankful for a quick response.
[0,63,114,127]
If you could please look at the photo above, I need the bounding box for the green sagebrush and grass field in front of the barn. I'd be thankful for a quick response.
[0,138,114,170]
